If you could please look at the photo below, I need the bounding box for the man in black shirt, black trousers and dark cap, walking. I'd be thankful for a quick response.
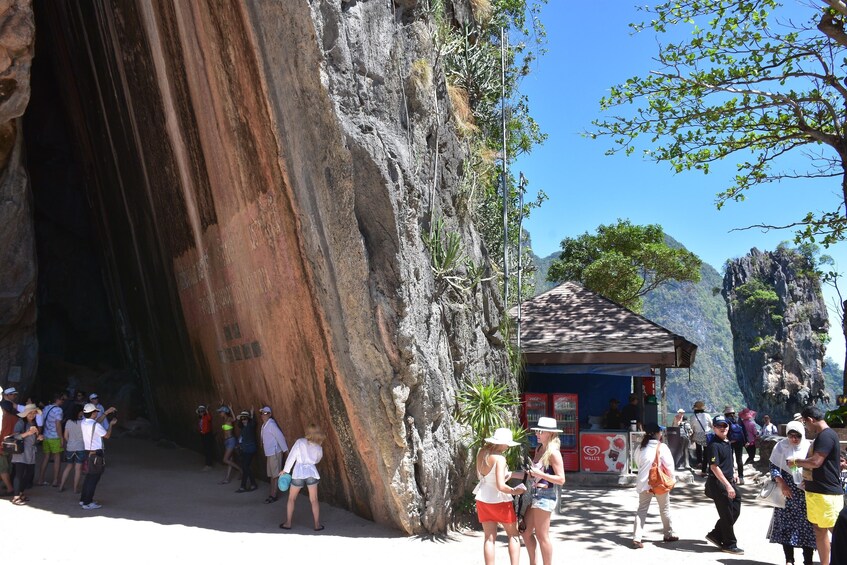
[705,416,744,555]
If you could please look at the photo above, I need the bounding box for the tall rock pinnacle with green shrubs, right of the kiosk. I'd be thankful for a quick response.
[723,247,829,422]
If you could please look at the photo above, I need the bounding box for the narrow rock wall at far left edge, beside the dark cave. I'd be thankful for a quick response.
[0,0,38,392]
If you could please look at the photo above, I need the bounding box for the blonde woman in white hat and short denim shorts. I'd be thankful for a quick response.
[523,417,565,565]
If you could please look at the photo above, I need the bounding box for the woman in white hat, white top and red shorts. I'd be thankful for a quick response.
[474,428,526,565]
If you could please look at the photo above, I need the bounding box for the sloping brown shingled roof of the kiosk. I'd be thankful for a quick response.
[509,282,697,367]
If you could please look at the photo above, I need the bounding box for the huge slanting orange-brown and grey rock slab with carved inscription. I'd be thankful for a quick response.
[11,0,507,533]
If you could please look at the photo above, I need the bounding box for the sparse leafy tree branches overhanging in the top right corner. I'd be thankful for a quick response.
[589,0,847,246]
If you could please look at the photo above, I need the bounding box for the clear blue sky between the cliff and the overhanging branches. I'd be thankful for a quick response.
[512,0,847,363]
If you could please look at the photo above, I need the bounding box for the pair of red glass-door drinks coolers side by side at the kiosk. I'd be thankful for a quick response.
[521,393,579,471]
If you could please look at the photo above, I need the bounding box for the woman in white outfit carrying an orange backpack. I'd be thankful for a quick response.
[632,423,679,549]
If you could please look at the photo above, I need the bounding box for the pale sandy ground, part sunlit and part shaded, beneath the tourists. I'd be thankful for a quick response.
[0,438,800,565]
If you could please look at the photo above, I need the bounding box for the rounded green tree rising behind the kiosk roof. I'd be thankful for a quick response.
[547,220,702,312]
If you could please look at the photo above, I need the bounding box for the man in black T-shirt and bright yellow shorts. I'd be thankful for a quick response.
[788,406,844,565]
